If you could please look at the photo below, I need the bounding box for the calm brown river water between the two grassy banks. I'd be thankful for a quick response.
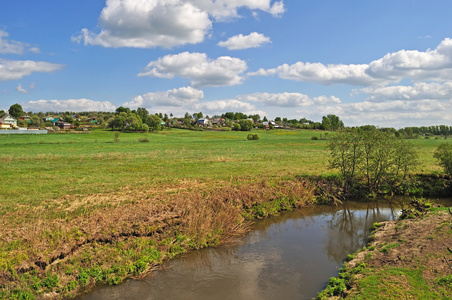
[78,202,424,300]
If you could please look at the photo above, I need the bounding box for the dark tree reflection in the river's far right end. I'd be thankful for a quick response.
[326,202,398,263]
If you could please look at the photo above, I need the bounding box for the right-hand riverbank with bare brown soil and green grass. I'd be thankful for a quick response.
[317,208,452,299]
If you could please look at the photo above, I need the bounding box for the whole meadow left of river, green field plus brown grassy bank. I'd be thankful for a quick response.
[0,129,444,299]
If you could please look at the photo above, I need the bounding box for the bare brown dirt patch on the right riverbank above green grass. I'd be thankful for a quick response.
[342,210,452,299]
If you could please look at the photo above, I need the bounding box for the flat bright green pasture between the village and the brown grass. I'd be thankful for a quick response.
[0,129,444,212]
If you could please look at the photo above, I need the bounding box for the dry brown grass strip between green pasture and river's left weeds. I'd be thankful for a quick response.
[0,180,314,298]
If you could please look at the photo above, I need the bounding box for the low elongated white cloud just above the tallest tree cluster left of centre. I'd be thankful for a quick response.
[123,87,204,109]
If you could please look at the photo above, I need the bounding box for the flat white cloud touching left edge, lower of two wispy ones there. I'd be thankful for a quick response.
[0,59,63,81]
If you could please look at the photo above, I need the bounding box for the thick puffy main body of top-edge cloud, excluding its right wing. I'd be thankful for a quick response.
[73,0,212,48]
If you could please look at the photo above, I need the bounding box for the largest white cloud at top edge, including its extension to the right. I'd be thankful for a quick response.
[73,0,284,48]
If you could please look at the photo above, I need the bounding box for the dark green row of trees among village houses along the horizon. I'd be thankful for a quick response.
[0,104,452,139]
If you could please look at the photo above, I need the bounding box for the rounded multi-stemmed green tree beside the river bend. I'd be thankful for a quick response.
[328,128,417,194]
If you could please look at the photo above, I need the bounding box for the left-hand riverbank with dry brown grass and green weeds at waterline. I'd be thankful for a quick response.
[0,180,315,299]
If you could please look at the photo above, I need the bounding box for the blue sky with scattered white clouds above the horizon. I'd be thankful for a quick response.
[0,0,452,128]
